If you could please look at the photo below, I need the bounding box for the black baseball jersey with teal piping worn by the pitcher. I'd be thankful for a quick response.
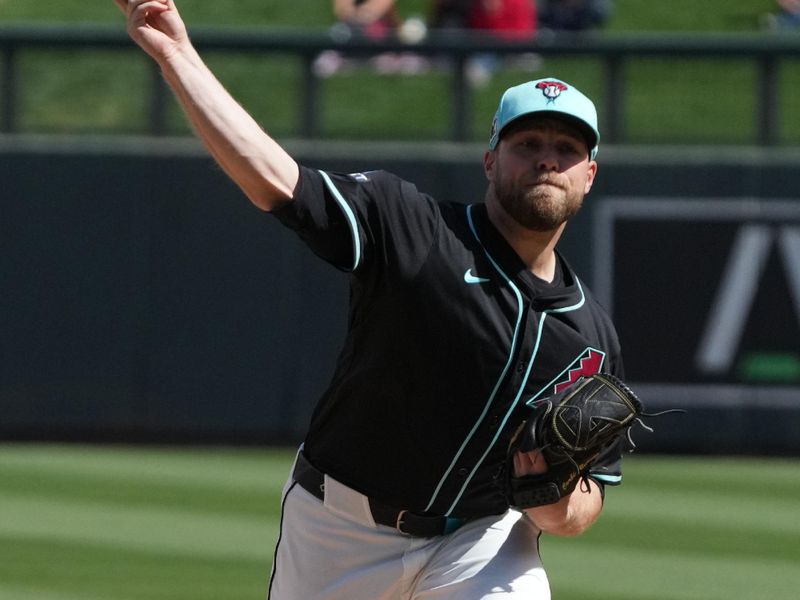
[273,167,622,517]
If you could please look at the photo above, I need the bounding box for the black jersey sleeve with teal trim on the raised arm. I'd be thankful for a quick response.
[272,167,441,274]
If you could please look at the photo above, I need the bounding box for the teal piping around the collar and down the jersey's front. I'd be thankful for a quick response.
[429,205,586,515]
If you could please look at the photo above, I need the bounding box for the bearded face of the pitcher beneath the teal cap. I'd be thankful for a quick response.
[484,117,597,231]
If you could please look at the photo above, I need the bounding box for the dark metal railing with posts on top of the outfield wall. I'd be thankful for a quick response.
[0,25,800,145]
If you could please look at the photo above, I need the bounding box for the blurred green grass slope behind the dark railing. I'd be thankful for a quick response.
[0,0,800,144]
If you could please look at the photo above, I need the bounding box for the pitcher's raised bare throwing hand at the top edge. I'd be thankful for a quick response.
[114,0,188,61]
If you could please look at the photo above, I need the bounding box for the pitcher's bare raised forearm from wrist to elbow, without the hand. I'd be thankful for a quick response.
[158,43,299,210]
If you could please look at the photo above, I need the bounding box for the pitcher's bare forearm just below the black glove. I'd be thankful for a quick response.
[525,479,603,536]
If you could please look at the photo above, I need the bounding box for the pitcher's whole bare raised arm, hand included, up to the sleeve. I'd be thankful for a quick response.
[114,0,299,211]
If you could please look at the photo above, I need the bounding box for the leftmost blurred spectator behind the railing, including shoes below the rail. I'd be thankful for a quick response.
[314,0,426,77]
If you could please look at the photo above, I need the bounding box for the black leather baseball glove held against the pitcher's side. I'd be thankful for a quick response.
[506,374,642,508]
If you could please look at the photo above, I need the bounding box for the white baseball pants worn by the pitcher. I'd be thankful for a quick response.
[268,454,550,600]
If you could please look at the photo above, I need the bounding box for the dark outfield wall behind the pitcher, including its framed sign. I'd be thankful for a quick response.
[0,137,800,454]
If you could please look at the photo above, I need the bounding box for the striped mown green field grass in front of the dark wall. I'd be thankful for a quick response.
[0,444,800,600]
